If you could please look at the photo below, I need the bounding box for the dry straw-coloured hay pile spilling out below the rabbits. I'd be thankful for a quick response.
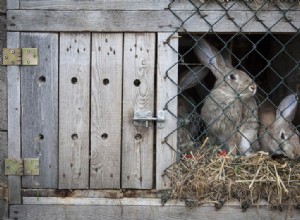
[166,138,300,210]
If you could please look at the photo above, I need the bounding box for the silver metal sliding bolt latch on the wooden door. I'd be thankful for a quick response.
[133,110,165,128]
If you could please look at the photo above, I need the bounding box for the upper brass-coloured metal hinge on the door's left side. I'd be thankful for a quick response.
[2,48,39,66]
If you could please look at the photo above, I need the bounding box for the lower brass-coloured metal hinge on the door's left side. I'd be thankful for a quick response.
[5,158,40,176]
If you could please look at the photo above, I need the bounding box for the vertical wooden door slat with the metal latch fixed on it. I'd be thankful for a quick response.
[122,33,155,189]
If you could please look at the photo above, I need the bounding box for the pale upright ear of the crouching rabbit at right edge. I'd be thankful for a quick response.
[276,94,298,122]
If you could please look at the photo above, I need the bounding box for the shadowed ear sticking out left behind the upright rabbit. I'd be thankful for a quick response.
[179,66,209,91]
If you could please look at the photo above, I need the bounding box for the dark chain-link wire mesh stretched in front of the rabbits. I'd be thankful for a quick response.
[163,0,300,159]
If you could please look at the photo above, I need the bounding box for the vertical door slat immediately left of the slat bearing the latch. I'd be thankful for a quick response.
[90,33,123,189]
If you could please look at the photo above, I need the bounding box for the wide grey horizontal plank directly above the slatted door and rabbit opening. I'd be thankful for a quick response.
[7,10,300,33]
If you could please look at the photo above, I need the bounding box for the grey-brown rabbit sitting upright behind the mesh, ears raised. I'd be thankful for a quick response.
[195,38,259,155]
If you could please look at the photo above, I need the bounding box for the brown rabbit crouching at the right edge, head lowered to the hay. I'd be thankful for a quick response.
[259,94,300,159]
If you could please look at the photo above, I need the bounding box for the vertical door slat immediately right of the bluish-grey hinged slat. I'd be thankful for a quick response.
[59,33,90,189]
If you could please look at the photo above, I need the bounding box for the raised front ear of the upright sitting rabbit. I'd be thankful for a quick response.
[194,38,226,79]
